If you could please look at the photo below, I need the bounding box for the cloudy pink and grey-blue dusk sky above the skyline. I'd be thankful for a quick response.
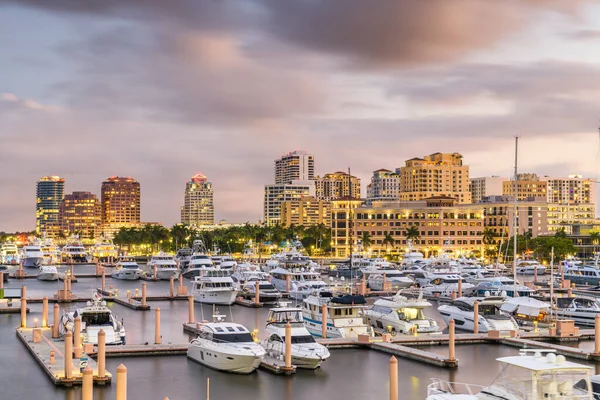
[0,0,600,231]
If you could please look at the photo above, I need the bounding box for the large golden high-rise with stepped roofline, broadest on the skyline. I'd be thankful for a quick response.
[396,153,471,204]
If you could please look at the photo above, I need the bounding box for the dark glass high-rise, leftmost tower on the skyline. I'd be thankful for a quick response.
[35,176,65,237]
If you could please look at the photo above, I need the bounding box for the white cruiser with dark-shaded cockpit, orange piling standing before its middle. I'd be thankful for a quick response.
[438,296,519,333]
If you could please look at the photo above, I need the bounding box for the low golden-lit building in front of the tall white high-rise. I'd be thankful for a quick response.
[281,196,331,226]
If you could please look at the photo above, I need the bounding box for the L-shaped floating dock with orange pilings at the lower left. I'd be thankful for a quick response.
[17,328,112,387]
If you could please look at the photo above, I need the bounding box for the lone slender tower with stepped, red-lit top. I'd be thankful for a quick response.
[181,174,215,228]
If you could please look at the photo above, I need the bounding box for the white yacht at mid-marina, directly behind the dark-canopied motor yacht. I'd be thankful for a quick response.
[269,267,327,300]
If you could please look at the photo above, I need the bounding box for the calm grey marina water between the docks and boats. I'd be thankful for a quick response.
[0,266,593,400]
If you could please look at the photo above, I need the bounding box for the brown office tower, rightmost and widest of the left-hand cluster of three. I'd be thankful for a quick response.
[100,176,140,234]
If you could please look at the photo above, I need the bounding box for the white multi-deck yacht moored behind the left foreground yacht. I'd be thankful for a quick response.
[192,268,238,305]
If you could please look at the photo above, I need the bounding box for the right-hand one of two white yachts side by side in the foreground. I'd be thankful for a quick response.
[262,303,330,369]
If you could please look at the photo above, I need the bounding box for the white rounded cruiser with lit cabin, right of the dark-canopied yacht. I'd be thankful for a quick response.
[364,292,441,336]
